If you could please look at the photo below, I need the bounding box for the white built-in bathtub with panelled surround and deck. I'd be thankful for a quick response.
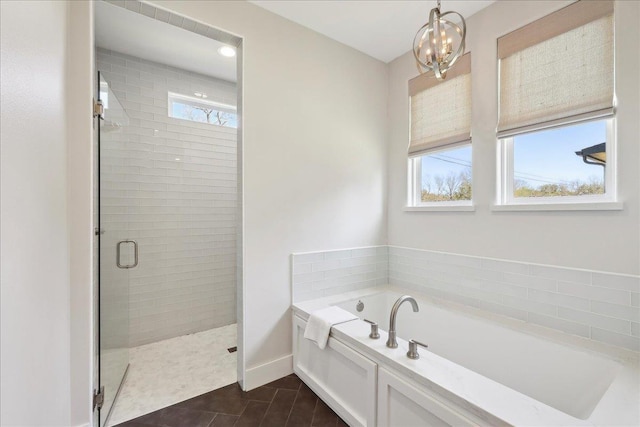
[293,287,640,426]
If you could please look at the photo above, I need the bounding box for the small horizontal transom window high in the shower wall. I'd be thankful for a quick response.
[168,92,238,128]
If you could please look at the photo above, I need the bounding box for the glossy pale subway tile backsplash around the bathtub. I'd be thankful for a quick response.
[292,246,640,351]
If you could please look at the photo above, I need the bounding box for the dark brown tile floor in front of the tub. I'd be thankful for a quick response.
[118,374,347,427]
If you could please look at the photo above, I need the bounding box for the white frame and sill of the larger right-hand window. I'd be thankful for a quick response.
[492,116,623,210]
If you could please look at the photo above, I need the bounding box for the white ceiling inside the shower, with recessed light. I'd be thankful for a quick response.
[95,1,236,82]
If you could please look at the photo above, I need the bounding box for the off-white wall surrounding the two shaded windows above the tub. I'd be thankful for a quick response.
[388,1,640,274]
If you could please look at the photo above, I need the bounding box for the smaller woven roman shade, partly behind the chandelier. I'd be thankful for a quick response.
[409,53,471,156]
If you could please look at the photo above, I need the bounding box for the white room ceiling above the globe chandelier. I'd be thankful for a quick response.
[249,0,494,62]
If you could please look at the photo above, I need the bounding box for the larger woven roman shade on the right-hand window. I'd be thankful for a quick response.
[498,0,614,137]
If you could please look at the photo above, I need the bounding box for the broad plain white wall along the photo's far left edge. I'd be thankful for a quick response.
[0,1,71,426]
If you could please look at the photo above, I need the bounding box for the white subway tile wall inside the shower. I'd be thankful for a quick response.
[96,49,238,346]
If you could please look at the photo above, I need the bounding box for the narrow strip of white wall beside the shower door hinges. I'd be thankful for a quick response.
[66,1,97,426]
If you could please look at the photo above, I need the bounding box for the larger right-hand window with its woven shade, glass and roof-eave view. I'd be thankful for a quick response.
[498,1,615,205]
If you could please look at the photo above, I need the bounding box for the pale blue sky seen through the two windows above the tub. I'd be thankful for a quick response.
[422,120,606,187]
